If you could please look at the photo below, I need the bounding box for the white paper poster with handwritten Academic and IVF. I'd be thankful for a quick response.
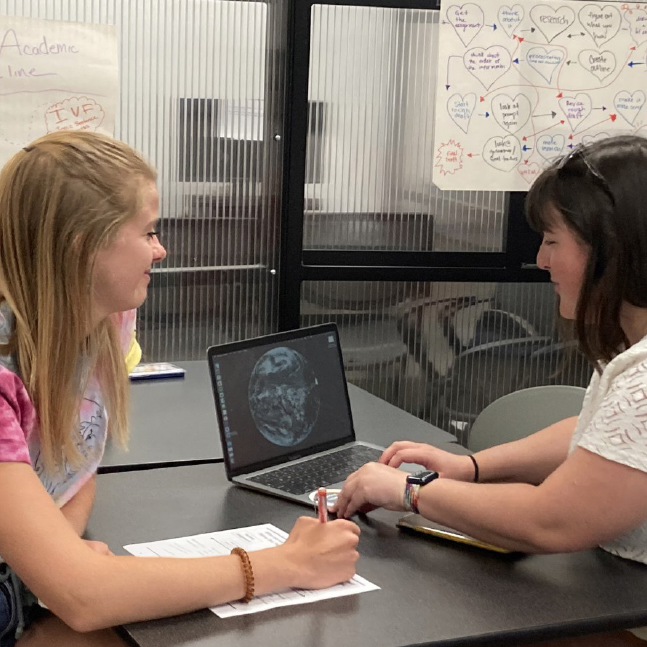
[0,16,118,167]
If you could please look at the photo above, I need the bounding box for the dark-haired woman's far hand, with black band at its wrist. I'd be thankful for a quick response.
[378,440,474,481]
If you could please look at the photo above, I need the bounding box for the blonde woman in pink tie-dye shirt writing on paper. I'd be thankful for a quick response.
[0,132,359,647]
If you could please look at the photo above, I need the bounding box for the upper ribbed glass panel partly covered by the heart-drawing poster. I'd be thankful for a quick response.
[304,5,507,252]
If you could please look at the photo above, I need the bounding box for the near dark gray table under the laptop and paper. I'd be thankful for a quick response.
[89,464,647,647]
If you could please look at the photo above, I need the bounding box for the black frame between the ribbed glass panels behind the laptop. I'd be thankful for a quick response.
[278,0,548,330]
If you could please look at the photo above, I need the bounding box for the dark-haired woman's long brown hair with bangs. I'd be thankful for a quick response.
[526,136,647,370]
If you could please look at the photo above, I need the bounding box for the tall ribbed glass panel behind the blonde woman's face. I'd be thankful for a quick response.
[0,0,285,360]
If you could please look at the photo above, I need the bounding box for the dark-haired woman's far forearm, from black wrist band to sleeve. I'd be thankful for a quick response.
[474,417,577,484]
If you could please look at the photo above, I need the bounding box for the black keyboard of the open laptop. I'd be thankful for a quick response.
[248,445,382,494]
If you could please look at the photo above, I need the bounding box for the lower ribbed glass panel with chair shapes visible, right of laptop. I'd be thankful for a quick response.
[301,281,591,444]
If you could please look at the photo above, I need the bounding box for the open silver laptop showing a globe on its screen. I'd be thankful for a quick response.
[208,324,383,505]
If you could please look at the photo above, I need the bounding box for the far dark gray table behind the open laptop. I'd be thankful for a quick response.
[100,361,456,472]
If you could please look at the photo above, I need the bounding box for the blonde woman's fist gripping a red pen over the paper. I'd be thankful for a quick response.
[281,517,360,589]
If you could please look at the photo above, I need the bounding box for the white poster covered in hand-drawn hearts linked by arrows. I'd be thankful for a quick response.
[433,0,647,191]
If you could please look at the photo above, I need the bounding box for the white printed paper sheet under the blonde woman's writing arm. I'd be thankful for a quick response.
[124,523,380,618]
